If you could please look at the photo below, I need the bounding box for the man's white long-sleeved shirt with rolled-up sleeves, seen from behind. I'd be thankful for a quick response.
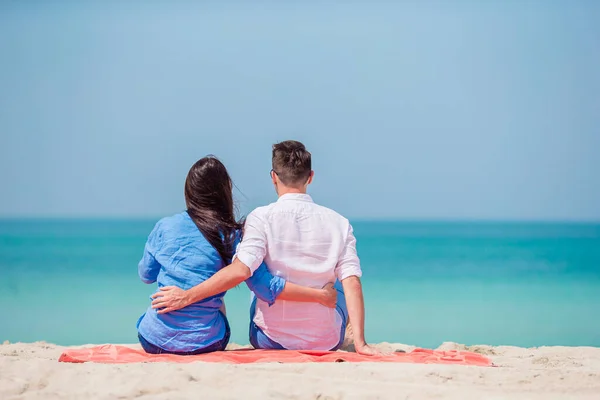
[236,194,362,350]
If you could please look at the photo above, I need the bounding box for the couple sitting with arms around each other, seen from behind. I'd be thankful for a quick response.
[137,141,378,355]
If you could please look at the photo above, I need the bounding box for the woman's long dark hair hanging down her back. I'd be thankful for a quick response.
[185,156,242,265]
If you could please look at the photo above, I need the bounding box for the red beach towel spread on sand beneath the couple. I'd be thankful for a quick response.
[58,344,492,367]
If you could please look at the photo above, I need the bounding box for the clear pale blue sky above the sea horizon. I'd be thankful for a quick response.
[0,1,600,220]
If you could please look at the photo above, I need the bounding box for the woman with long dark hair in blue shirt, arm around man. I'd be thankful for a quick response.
[137,156,335,355]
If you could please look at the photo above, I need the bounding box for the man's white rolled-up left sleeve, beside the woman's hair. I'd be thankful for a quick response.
[235,210,267,274]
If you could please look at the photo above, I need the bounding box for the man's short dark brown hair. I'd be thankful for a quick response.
[273,140,312,186]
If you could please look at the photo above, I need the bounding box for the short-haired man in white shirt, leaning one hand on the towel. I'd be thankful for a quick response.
[153,140,378,355]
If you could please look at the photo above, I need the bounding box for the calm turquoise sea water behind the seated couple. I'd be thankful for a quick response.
[0,220,600,347]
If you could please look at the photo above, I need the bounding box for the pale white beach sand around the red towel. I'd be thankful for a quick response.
[0,343,600,400]
